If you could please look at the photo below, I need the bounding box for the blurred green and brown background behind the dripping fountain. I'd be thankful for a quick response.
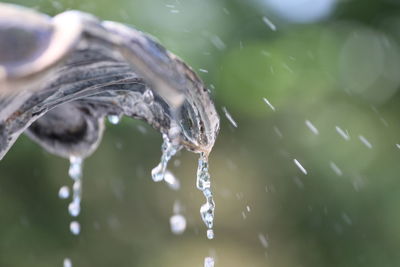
[0,0,400,267]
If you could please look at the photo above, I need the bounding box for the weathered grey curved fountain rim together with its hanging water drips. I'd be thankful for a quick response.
[0,1,219,264]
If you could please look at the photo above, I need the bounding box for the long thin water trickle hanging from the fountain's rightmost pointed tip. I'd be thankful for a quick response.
[196,153,215,239]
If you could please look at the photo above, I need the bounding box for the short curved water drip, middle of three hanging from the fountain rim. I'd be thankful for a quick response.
[151,134,180,183]
